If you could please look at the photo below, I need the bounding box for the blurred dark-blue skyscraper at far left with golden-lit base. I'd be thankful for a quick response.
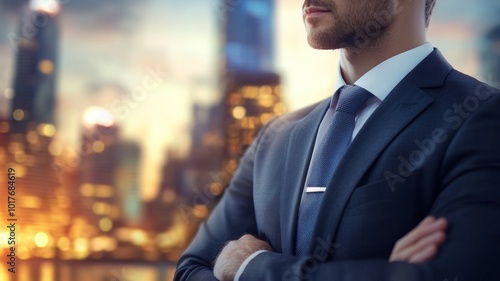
[0,1,63,259]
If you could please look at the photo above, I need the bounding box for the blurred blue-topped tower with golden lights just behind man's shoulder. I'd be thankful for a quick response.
[214,0,285,186]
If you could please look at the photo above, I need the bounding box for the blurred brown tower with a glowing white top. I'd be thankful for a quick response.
[76,112,123,233]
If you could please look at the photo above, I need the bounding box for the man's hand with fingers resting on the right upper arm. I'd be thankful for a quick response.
[389,217,448,263]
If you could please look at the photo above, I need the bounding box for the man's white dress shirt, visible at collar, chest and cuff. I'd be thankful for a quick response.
[234,43,433,281]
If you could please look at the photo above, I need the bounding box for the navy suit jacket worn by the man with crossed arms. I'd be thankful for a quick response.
[175,50,500,281]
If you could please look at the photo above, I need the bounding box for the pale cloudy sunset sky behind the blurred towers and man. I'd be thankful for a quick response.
[0,0,500,200]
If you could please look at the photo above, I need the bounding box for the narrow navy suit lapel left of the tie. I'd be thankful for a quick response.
[280,99,330,255]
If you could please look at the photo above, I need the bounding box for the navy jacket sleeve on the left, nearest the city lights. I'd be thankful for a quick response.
[174,121,272,281]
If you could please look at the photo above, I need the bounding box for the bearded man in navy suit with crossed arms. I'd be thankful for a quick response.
[175,0,500,281]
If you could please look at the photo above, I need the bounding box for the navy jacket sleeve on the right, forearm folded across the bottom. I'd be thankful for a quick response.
[236,95,500,281]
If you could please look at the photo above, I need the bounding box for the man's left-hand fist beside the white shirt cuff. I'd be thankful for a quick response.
[214,234,272,281]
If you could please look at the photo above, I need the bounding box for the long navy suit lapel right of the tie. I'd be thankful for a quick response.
[308,50,451,253]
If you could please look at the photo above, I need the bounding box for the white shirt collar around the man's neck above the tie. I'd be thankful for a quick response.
[334,43,433,101]
